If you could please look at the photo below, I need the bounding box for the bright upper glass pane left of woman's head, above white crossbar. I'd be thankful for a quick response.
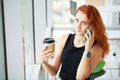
[53,0,70,25]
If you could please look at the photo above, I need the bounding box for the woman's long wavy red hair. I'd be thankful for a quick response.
[76,5,109,57]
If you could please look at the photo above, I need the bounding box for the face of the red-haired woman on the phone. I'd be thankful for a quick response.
[74,11,89,36]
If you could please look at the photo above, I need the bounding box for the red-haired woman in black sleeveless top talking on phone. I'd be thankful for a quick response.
[40,5,109,80]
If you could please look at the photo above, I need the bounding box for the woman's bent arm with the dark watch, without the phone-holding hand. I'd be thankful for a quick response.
[76,44,103,80]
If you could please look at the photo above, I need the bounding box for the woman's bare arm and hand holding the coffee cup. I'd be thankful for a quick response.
[40,35,68,76]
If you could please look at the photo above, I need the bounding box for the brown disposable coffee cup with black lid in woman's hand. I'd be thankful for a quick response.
[43,38,55,57]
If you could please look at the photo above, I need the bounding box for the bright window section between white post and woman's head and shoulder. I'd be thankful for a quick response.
[52,0,77,39]
